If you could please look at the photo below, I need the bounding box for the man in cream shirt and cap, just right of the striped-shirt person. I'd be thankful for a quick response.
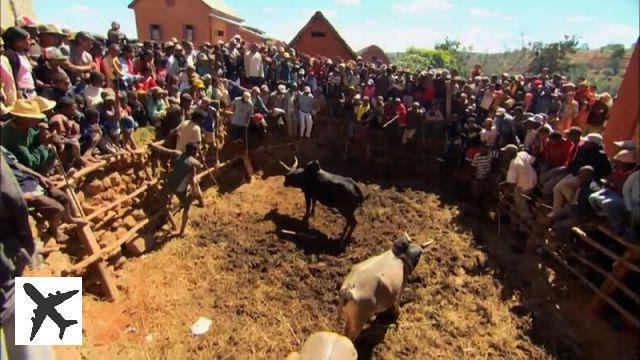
[500,144,538,219]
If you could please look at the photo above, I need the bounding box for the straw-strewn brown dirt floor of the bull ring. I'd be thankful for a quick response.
[66,150,635,359]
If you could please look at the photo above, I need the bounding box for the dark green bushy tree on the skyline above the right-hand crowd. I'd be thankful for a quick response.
[530,35,579,73]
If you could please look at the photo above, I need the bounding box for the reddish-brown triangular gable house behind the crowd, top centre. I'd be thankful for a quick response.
[289,11,356,61]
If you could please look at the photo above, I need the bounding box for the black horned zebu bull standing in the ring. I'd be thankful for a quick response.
[280,157,365,246]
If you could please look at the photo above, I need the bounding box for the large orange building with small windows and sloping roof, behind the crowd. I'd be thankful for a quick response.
[129,0,265,45]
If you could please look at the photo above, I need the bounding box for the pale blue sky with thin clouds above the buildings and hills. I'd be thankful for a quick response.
[33,0,640,52]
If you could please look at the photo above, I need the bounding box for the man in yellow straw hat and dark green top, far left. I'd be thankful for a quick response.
[1,99,55,175]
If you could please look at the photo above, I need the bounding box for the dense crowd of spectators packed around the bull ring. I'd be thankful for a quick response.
[0,18,640,358]
